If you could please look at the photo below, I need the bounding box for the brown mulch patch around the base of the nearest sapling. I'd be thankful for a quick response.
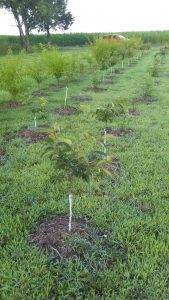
[30,215,87,258]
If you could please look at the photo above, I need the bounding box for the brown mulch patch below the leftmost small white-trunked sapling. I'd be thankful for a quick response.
[19,128,48,142]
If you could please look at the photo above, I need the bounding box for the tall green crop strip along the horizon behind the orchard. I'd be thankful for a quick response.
[0,30,169,54]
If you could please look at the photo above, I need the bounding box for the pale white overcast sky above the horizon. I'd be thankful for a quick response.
[0,0,169,34]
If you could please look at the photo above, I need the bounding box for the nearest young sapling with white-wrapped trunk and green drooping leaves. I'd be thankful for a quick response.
[45,123,109,232]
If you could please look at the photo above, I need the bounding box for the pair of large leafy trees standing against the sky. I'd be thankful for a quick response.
[0,0,74,52]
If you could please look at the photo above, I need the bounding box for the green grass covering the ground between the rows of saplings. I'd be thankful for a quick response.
[0,47,169,300]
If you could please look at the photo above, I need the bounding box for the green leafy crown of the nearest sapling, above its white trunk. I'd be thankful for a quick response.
[45,123,111,184]
